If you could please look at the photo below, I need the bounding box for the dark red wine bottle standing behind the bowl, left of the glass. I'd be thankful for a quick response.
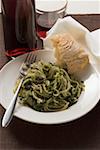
[2,0,43,50]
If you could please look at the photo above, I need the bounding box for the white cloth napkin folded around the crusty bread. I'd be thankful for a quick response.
[44,16,100,74]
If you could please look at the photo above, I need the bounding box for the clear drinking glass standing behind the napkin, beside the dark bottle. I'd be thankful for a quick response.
[36,0,67,28]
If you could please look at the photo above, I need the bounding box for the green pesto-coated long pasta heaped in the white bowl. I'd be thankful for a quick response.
[16,61,85,112]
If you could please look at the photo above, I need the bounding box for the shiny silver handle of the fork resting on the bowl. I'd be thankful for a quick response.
[2,78,23,127]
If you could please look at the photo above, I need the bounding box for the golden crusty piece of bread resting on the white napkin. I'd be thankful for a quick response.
[51,33,89,74]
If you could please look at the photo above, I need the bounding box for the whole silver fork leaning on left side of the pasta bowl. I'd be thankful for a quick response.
[2,53,36,127]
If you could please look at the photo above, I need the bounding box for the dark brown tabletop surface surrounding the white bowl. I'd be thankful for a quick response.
[0,14,100,150]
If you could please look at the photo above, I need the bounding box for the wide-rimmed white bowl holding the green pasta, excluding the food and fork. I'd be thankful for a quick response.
[0,50,100,124]
